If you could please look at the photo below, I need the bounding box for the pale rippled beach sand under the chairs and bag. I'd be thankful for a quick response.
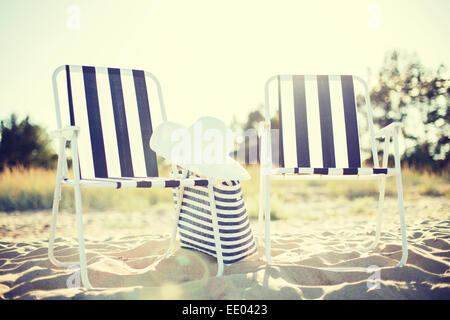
[0,197,450,299]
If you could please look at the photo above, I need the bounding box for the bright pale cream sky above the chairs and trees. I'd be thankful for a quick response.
[0,0,450,129]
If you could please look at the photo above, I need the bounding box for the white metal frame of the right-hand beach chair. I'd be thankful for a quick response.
[258,75,408,270]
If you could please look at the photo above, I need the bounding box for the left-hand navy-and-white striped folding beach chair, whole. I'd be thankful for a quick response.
[48,65,223,288]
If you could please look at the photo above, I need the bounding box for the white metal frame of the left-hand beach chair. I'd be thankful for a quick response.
[48,66,224,289]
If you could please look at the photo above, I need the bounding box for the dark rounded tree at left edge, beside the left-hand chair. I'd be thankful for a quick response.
[0,114,57,172]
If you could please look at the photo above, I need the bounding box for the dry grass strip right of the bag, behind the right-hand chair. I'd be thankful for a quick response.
[242,166,450,219]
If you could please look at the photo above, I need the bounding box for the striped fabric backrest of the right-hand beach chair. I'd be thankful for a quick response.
[266,75,373,168]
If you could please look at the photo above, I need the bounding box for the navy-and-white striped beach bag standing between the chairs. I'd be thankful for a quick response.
[174,171,257,265]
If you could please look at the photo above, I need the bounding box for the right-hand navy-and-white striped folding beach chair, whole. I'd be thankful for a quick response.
[259,75,408,266]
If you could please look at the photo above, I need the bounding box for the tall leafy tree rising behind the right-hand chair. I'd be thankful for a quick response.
[370,50,450,171]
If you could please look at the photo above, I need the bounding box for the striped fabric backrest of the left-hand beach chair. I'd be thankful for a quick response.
[53,65,167,179]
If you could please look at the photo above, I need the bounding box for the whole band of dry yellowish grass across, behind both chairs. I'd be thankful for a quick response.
[0,166,450,219]
